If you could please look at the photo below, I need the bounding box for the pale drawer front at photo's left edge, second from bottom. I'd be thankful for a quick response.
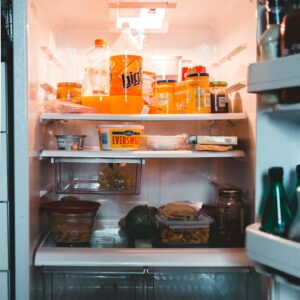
[0,202,8,271]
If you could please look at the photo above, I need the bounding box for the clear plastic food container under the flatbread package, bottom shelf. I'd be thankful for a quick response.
[155,213,215,247]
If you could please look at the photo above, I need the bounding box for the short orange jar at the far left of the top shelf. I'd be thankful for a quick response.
[56,82,82,104]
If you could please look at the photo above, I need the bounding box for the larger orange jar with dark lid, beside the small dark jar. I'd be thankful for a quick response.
[186,73,211,114]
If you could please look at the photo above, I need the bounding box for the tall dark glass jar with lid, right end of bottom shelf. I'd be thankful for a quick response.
[216,188,245,247]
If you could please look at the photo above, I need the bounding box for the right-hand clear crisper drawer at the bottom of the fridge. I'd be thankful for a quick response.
[150,268,250,300]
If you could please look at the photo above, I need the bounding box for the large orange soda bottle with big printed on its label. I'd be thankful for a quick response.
[109,23,143,114]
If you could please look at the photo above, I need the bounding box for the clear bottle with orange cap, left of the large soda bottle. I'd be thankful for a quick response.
[83,39,109,96]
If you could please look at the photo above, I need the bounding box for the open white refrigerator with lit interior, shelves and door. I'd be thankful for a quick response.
[9,0,300,300]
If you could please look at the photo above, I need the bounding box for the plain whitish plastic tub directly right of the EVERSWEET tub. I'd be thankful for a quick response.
[144,134,188,151]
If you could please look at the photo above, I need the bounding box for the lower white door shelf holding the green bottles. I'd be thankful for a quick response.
[246,223,300,278]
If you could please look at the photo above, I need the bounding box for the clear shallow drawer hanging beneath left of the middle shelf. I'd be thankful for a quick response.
[53,158,144,195]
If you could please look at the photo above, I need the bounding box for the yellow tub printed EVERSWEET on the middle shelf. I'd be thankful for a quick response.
[98,124,144,150]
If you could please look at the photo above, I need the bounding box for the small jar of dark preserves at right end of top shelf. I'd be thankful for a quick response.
[210,81,228,113]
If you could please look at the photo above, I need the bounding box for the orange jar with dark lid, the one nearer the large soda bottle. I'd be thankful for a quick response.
[156,79,176,114]
